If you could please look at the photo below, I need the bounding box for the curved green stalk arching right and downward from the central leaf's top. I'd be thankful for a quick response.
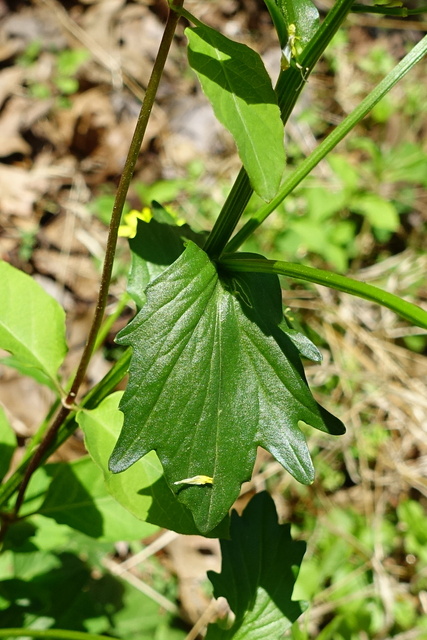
[219,254,427,329]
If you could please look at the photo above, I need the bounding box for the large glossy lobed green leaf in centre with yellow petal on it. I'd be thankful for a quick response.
[110,242,343,532]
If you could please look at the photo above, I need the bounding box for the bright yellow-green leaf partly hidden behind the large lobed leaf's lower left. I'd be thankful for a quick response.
[77,392,228,536]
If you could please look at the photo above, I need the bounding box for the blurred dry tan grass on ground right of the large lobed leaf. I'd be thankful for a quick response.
[236,250,427,640]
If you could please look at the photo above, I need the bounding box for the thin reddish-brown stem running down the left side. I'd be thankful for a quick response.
[6,0,183,517]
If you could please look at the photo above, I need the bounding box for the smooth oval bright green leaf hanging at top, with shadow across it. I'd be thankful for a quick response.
[185,26,285,202]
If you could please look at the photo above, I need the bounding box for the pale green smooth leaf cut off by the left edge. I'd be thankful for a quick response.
[0,261,67,388]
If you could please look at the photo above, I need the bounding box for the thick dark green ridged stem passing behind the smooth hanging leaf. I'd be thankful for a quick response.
[204,0,353,259]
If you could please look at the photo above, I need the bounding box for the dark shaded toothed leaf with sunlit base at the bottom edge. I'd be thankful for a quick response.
[206,492,305,640]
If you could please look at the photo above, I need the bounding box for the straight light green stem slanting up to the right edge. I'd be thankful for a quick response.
[226,36,427,253]
